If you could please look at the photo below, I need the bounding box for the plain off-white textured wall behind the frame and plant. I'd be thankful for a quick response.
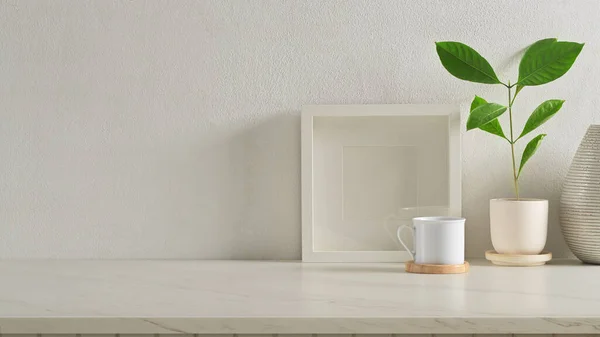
[0,0,600,259]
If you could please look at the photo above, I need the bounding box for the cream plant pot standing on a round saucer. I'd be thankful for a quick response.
[490,198,548,255]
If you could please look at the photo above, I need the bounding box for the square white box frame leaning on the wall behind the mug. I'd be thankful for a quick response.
[301,104,461,262]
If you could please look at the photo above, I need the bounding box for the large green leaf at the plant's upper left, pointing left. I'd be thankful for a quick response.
[435,41,500,84]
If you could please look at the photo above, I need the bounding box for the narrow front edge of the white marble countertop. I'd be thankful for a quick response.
[0,317,600,334]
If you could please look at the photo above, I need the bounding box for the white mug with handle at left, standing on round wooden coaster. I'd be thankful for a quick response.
[396,216,465,264]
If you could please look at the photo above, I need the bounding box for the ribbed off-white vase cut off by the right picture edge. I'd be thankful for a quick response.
[560,125,600,264]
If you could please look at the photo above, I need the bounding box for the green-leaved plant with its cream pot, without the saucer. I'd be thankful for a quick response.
[435,38,583,255]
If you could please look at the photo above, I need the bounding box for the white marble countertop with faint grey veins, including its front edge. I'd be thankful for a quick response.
[0,261,600,334]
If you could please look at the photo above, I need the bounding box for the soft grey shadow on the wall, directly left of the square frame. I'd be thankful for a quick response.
[210,112,301,259]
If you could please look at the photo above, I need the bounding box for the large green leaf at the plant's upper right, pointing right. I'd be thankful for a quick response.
[517,39,584,86]
